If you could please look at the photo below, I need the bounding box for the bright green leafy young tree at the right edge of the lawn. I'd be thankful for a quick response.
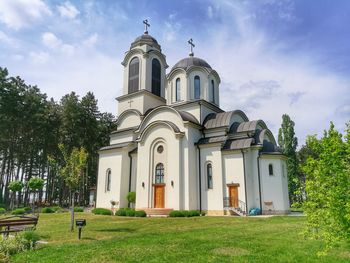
[302,123,350,253]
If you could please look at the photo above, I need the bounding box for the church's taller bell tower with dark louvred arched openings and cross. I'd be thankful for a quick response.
[117,20,168,115]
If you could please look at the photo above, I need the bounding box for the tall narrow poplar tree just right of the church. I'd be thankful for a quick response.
[278,114,302,204]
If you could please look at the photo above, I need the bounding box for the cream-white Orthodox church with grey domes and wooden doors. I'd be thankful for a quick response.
[96,20,289,216]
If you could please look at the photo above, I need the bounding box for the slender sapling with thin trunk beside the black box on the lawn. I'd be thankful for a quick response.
[59,144,88,231]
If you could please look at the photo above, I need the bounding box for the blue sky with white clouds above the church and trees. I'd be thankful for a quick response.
[0,0,350,145]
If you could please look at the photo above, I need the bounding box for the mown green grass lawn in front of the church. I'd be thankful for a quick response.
[11,213,350,263]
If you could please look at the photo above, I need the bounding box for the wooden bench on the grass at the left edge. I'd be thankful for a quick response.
[0,215,39,236]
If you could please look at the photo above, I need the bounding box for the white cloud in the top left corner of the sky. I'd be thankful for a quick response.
[0,0,51,29]
